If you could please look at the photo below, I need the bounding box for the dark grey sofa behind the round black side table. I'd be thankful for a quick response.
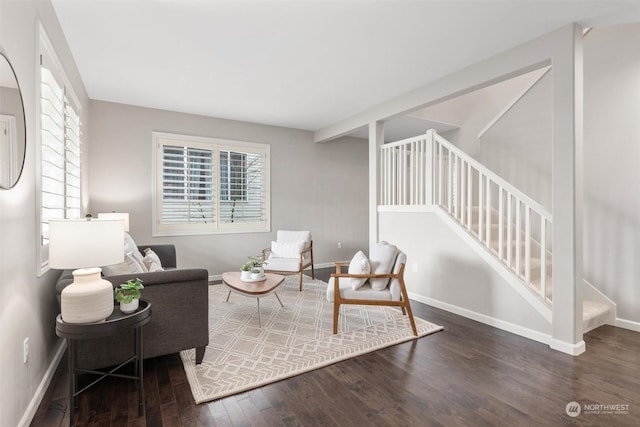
[56,245,209,369]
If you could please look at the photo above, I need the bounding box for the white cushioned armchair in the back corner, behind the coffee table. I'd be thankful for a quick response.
[262,230,316,291]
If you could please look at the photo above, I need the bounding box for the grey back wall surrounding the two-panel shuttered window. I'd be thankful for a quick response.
[90,101,368,276]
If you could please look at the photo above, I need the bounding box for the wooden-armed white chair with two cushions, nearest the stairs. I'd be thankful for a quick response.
[327,242,418,336]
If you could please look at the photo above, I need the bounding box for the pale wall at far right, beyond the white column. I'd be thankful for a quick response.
[584,24,640,324]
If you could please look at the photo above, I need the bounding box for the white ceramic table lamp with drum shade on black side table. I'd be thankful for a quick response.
[49,219,124,323]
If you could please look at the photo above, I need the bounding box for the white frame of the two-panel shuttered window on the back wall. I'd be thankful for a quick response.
[151,131,271,237]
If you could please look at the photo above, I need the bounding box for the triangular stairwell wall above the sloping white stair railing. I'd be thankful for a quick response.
[416,70,552,211]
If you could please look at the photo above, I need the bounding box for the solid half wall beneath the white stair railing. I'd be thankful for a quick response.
[379,212,551,339]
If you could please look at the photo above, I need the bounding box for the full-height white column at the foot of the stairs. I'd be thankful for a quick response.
[550,25,585,355]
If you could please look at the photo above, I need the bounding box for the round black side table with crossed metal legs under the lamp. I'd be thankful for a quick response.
[56,299,151,426]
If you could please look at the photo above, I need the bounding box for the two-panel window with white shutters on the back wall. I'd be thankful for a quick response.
[153,132,270,235]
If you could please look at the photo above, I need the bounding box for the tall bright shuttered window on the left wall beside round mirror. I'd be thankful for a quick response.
[39,28,82,271]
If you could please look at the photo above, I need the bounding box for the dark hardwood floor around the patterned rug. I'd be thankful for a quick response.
[32,269,640,427]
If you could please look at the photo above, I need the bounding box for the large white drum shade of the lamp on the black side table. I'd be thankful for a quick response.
[49,219,124,269]
